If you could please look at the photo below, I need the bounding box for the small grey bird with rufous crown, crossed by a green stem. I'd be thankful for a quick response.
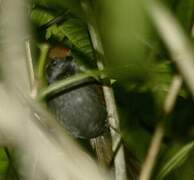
[45,47,107,139]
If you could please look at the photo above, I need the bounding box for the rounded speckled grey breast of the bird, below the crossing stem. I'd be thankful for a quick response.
[48,84,107,138]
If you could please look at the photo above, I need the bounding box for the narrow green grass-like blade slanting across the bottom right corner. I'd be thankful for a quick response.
[157,142,194,180]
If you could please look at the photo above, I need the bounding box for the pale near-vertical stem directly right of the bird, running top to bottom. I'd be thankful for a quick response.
[81,0,127,180]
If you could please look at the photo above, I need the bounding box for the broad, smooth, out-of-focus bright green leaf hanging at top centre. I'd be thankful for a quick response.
[95,0,151,81]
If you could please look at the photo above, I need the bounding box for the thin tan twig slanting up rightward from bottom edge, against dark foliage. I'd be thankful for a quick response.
[139,75,182,180]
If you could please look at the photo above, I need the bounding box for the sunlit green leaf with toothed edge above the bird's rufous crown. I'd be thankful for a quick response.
[31,8,94,59]
